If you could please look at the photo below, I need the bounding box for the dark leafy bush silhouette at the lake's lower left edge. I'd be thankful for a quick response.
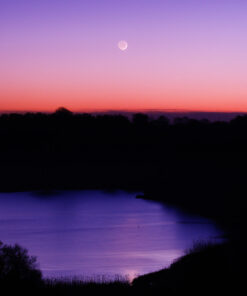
[0,241,42,288]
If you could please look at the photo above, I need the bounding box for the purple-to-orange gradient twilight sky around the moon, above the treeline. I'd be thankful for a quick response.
[0,0,247,111]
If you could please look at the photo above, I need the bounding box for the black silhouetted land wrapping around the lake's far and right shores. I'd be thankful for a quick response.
[0,108,247,295]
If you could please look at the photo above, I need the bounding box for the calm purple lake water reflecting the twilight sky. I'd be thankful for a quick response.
[0,191,223,279]
